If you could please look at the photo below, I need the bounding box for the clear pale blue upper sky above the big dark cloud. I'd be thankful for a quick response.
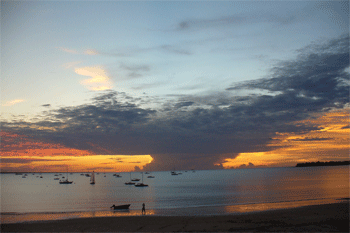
[1,1,349,118]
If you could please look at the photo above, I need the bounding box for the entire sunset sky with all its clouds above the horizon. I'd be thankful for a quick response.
[0,1,350,172]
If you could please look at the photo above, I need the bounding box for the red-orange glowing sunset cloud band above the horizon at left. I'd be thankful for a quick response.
[0,132,153,172]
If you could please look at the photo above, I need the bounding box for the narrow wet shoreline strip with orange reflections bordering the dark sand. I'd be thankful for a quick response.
[1,198,349,224]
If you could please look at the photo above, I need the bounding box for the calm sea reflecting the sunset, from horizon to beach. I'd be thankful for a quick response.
[0,166,349,223]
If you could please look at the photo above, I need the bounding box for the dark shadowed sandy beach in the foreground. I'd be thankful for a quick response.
[1,202,349,232]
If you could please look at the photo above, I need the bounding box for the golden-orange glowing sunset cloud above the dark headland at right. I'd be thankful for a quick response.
[223,111,350,168]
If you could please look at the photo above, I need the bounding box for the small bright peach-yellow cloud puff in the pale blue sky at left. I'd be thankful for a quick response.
[74,66,112,91]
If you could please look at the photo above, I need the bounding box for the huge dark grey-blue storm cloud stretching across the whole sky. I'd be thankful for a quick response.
[2,36,349,170]
